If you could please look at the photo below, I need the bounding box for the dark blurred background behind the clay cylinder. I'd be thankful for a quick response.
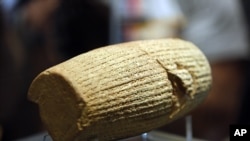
[0,0,250,141]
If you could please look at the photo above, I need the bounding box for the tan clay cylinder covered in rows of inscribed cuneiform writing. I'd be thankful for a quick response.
[29,39,211,141]
